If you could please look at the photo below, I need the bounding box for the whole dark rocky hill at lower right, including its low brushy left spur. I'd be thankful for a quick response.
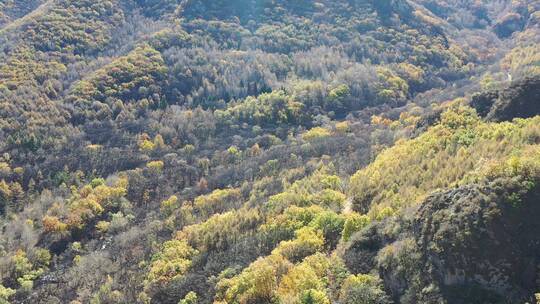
[342,178,540,304]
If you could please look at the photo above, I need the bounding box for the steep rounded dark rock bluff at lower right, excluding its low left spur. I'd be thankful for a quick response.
[414,180,540,303]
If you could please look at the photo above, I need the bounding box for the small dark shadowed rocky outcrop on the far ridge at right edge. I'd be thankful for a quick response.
[471,76,540,121]
